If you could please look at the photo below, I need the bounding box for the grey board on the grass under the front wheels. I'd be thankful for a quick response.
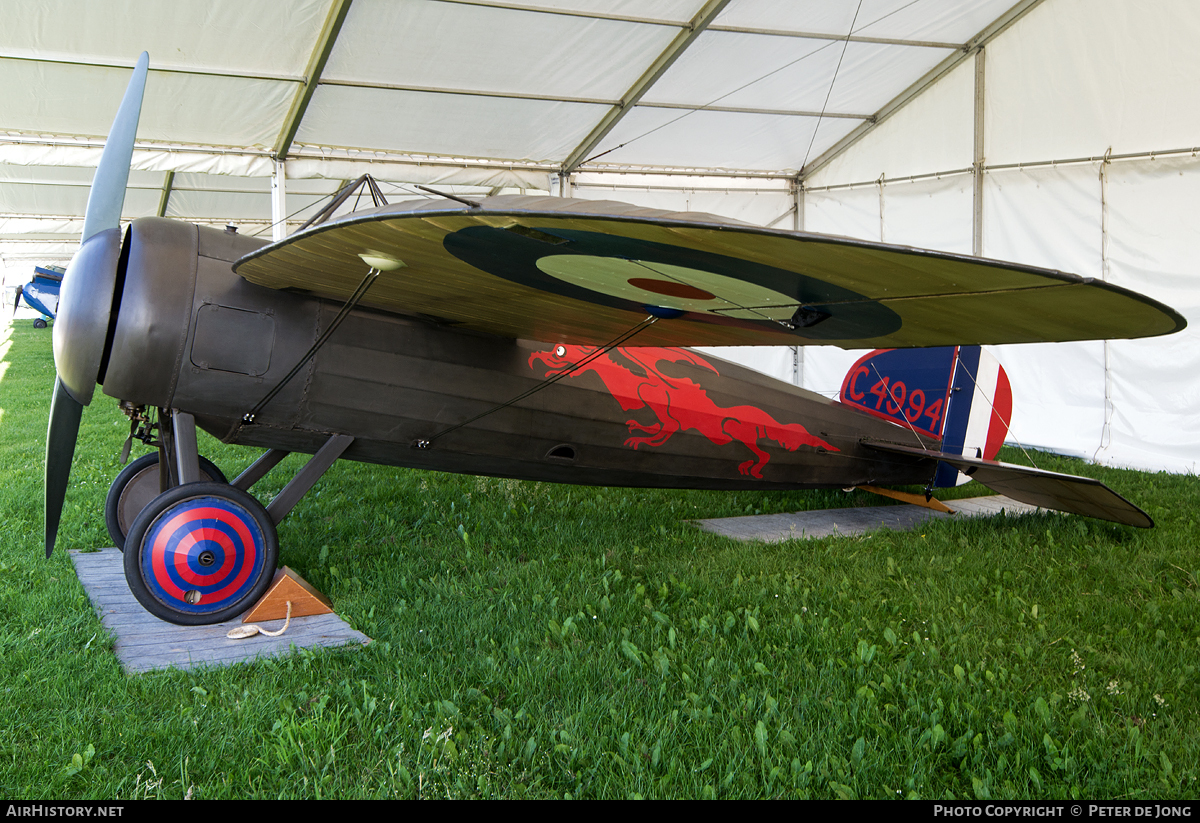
[70,548,371,673]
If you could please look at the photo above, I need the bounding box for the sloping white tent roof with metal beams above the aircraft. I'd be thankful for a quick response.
[0,0,1031,244]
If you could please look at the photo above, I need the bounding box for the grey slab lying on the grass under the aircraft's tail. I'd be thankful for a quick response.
[695,494,1038,542]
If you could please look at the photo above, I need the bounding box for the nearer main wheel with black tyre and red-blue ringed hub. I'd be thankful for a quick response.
[125,482,280,626]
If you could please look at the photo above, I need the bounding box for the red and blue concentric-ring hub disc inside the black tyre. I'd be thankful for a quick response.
[140,497,266,614]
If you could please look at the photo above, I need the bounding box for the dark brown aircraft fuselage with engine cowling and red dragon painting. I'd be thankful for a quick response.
[101,218,934,489]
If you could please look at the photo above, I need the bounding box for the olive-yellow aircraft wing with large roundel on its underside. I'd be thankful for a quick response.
[234,196,1186,349]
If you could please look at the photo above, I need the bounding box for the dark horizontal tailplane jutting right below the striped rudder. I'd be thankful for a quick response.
[863,440,1154,529]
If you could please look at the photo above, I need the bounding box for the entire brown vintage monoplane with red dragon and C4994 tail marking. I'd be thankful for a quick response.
[46,55,1184,624]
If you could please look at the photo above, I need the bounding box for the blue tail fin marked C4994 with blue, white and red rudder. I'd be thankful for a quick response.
[840,346,1013,488]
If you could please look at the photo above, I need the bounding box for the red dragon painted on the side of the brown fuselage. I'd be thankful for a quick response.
[529,346,839,480]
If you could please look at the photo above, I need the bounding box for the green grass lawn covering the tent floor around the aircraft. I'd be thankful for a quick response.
[0,322,1200,799]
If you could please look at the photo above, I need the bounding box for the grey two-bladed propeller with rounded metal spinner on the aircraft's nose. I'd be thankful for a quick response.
[46,52,150,557]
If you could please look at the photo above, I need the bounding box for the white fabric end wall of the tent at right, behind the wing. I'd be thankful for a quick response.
[803,0,1200,471]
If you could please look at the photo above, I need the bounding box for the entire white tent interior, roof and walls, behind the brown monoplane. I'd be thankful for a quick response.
[0,0,1200,471]
